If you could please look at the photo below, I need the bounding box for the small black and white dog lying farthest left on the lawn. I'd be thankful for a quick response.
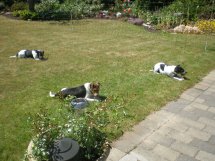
[10,50,44,60]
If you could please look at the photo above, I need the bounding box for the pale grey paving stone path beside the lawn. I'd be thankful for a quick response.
[106,70,215,161]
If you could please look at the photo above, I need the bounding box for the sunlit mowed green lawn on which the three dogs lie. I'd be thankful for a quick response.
[0,16,215,161]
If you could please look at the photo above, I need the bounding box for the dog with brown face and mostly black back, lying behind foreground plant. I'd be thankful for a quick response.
[49,83,100,101]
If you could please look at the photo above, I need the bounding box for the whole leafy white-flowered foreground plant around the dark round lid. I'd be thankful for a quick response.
[26,106,107,161]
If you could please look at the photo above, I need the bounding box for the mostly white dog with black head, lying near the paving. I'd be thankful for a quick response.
[152,62,187,81]
